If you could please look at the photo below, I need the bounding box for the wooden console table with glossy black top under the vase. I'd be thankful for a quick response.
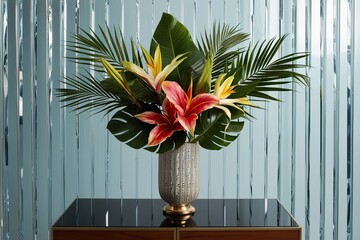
[51,199,301,240]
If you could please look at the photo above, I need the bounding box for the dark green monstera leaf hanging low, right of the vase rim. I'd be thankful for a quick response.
[195,109,244,150]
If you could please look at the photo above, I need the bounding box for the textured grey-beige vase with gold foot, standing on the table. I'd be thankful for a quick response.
[159,143,200,215]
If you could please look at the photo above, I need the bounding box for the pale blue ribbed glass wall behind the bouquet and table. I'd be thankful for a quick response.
[0,0,360,240]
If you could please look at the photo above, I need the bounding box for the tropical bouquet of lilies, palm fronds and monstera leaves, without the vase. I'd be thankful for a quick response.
[58,13,309,153]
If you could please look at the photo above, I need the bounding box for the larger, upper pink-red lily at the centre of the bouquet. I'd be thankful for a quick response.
[162,81,219,136]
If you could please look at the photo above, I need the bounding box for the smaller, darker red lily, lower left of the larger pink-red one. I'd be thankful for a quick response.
[135,98,184,146]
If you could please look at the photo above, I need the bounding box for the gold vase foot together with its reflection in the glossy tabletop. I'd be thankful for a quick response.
[163,204,195,225]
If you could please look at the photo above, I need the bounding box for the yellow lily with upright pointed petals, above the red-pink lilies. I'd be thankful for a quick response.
[122,45,186,93]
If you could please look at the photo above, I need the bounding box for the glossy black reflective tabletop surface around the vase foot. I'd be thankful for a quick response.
[53,199,298,227]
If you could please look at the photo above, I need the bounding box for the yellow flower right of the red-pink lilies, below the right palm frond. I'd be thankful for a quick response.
[214,73,256,119]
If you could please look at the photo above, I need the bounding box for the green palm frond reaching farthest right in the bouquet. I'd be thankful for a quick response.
[232,35,309,100]
